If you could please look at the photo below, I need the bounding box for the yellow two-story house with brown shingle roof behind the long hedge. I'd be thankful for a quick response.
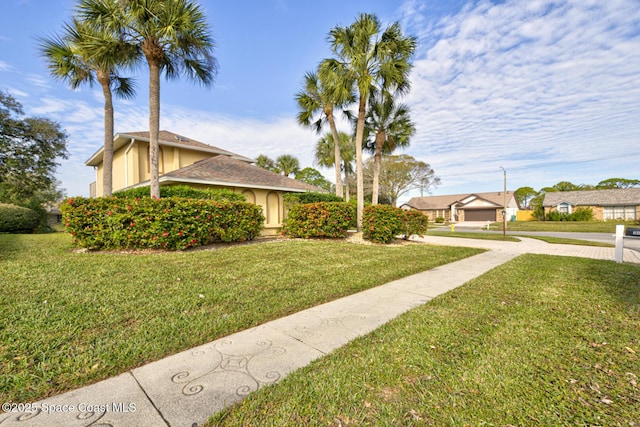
[85,131,324,234]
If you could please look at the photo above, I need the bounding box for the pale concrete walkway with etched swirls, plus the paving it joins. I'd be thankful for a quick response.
[0,236,640,427]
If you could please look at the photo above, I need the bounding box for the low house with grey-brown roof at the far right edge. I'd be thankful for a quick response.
[542,188,640,221]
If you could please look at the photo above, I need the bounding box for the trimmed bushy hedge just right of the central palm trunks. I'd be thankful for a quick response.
[362,205,428,243]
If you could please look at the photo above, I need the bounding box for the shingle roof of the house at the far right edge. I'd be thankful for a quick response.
[542,188,640,206]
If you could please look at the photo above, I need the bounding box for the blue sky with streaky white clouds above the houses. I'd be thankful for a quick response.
[0,0,640,201]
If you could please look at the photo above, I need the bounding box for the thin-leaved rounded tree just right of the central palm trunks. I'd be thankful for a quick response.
[365,154,440,206]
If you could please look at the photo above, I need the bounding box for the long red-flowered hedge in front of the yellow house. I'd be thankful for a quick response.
[60,197,264,250]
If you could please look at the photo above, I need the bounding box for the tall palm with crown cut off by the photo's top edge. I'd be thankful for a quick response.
[78,0,217,197]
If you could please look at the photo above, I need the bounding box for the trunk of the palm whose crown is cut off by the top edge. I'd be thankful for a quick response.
[147,58,160,198]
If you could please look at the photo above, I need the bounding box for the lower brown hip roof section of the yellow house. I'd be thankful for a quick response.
[160,156,324,192]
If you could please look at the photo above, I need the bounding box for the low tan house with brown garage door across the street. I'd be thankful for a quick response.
[401,191,518,222]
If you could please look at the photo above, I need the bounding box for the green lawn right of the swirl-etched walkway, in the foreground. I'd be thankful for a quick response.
[210,255,640,426]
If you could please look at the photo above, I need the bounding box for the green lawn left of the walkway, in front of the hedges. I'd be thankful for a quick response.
[0,233,481,402]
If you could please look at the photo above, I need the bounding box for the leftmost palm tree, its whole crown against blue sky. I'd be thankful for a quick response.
[40,19,135,196]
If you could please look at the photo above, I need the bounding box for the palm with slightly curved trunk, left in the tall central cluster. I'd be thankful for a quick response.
[296,62,355,197]
